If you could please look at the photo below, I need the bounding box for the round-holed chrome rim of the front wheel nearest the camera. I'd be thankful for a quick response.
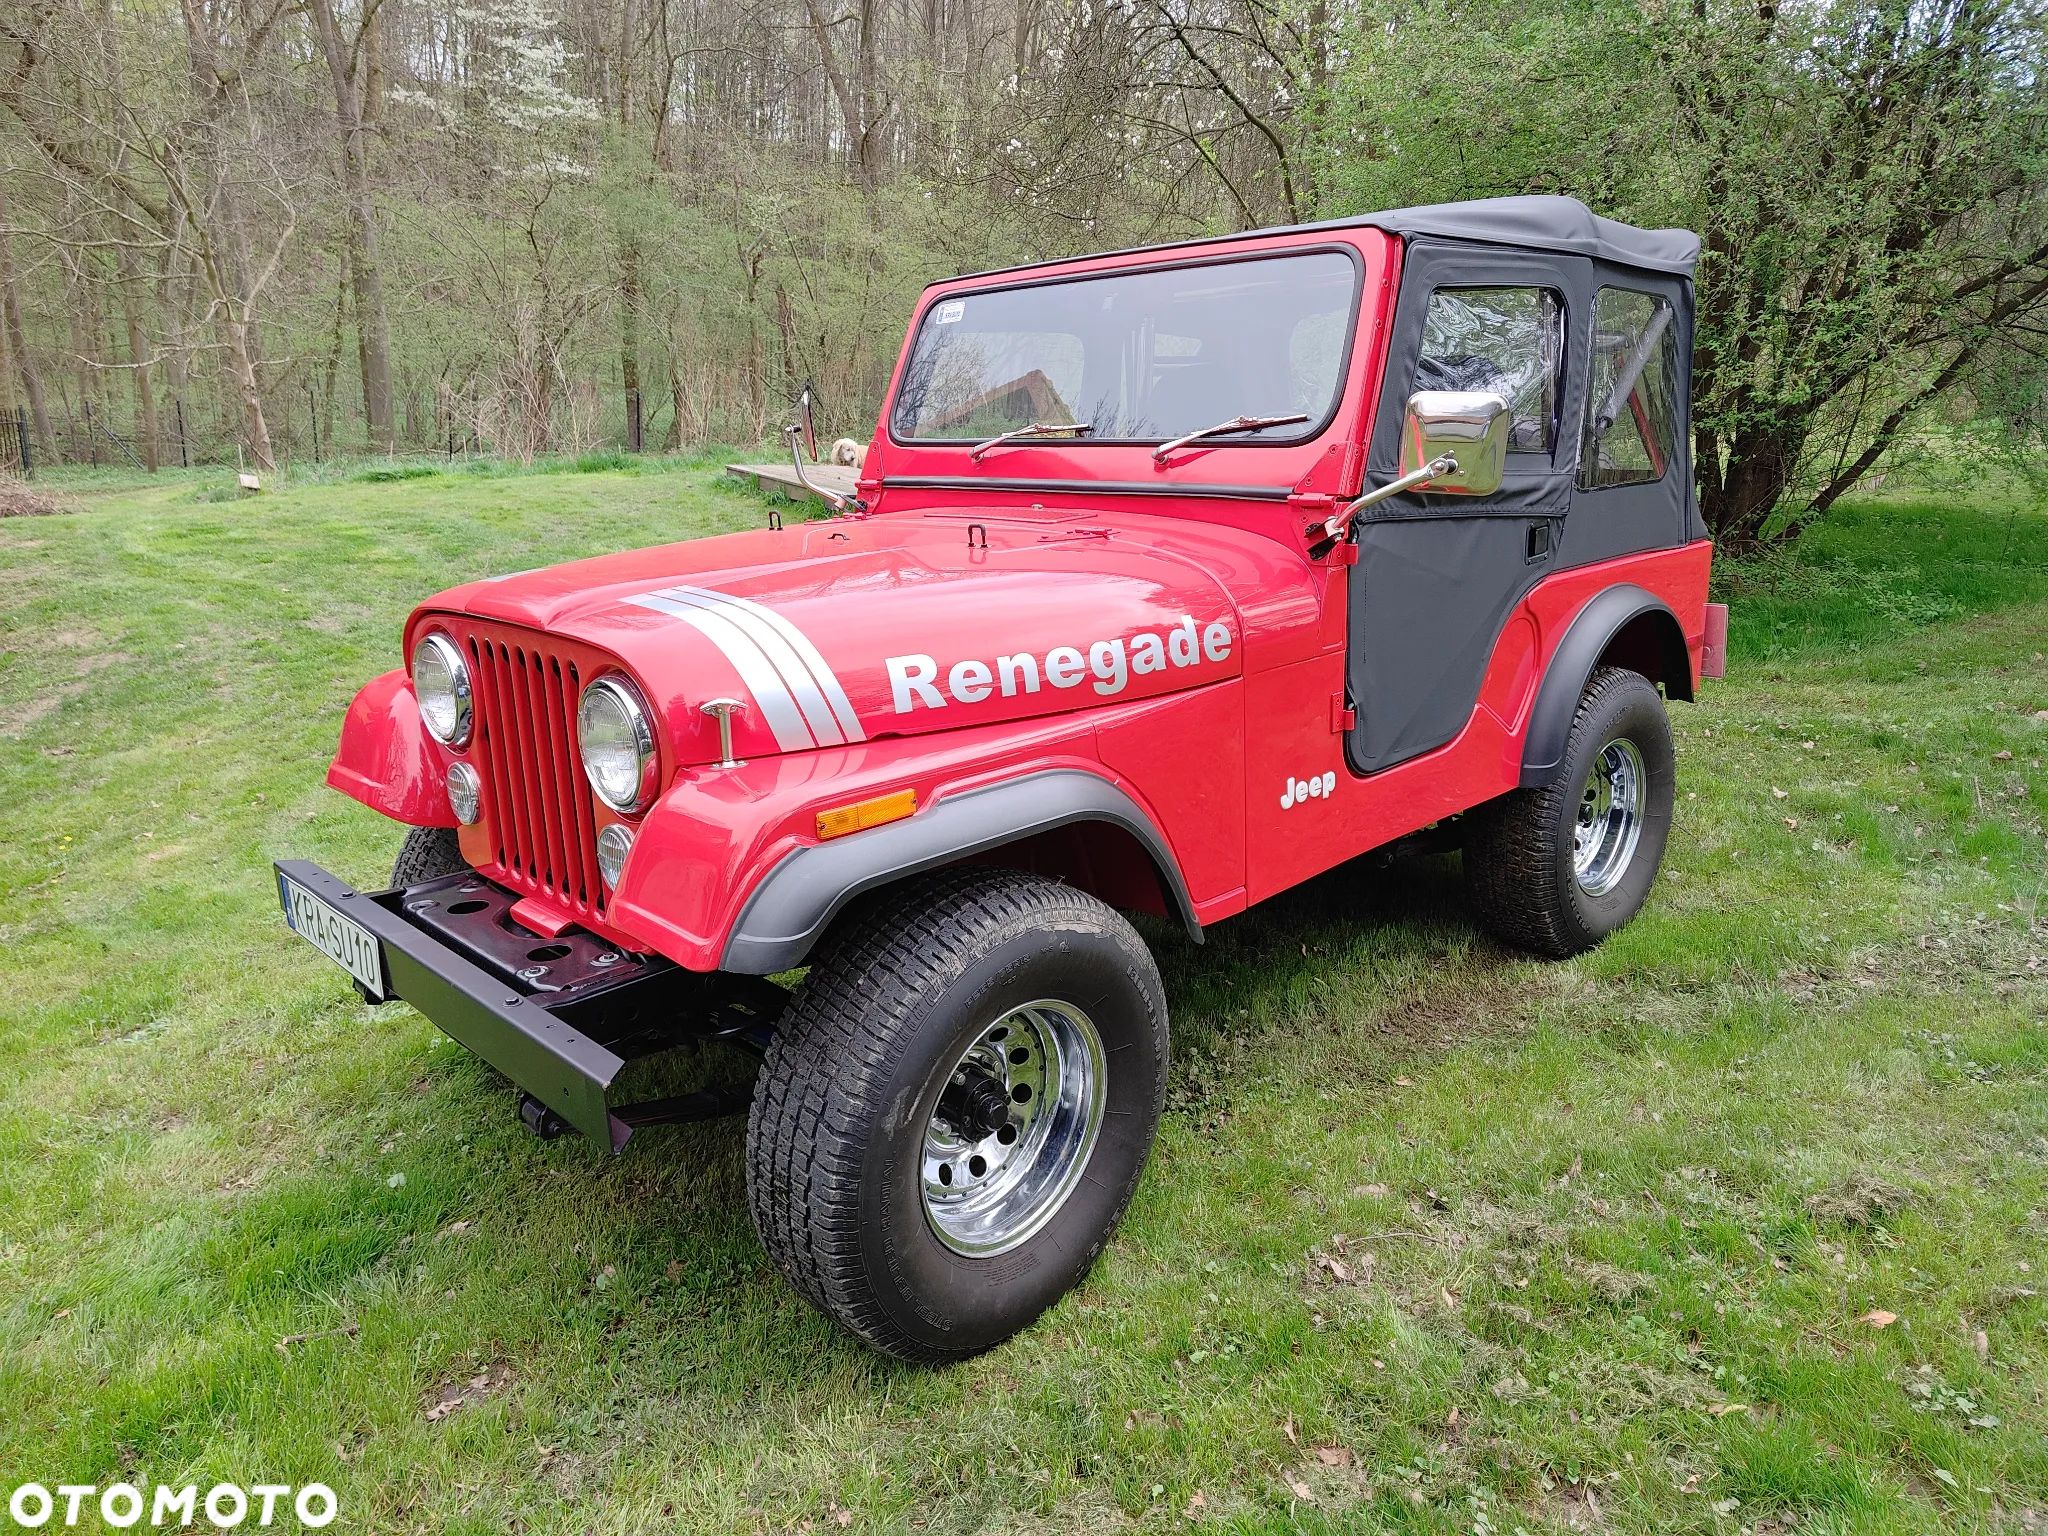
[924,999,1108,1257]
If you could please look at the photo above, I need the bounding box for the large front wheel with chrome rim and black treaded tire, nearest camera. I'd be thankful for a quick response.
[748,870,1167,1362]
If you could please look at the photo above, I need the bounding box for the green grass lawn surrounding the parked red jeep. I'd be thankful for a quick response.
[0,463,2048,1536]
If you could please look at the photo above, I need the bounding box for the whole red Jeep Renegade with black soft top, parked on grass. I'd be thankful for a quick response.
[276,197,1718,1360]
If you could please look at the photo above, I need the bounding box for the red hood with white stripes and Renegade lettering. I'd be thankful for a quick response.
[408,512,1298,764]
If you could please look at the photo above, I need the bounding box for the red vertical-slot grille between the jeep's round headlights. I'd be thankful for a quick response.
[465,633,604,915]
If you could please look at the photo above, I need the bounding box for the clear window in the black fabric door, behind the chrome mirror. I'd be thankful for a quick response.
[1415,289,1565,453]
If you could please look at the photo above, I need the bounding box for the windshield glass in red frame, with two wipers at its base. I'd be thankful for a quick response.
[889,250,1358,446]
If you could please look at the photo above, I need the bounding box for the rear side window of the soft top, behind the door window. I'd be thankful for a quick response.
[1579,289,1677,492]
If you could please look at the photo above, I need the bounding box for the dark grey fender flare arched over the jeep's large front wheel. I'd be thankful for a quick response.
[719,768,1202,977]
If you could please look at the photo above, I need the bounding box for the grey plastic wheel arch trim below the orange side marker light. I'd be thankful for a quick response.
[719,768,1202,975]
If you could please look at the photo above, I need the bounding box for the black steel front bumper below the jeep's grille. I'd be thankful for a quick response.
[276,858,786,1151]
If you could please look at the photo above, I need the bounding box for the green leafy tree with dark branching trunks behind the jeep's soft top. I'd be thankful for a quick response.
[1321,0,2048,547]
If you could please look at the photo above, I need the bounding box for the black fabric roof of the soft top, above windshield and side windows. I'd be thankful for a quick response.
[932,197,1700,287]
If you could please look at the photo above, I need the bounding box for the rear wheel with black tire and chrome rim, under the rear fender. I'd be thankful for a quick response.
[1464,668,1677,958]
